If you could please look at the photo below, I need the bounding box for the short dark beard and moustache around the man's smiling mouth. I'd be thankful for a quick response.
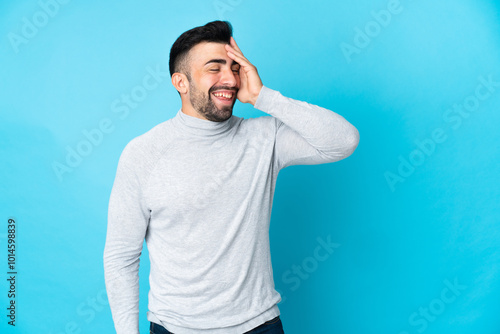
[189,81,238,122]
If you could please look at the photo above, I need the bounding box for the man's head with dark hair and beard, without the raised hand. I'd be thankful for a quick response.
[169,21,240,122]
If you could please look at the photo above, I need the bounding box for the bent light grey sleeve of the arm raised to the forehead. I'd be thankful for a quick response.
[254,86,359,169]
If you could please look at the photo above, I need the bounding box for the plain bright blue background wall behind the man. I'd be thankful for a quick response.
[0,0,500,334]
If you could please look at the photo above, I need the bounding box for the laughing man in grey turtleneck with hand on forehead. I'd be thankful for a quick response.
[104,21,359,334]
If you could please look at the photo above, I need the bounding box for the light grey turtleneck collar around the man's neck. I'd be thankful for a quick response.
[172,109,235,136]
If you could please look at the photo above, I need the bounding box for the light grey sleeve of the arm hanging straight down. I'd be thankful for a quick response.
[104,142,149,334]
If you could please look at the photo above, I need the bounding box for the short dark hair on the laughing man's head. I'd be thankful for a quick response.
[169,21,233,78]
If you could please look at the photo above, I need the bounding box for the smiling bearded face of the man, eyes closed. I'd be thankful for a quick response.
[189,42,240,122]
